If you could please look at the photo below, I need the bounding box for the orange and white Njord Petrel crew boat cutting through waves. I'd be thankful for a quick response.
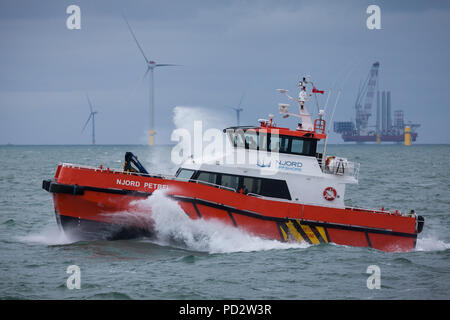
[43,78,424,251]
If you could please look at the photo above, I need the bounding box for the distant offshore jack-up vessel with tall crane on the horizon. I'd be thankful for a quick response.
[334,62,420,145]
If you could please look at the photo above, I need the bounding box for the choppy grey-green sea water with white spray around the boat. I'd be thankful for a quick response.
[0,145,450,299]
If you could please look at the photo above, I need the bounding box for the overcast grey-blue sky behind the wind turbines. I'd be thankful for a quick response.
[0,0,450,144]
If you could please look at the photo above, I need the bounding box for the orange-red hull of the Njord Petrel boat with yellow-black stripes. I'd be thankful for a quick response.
[43,165,423,251]
